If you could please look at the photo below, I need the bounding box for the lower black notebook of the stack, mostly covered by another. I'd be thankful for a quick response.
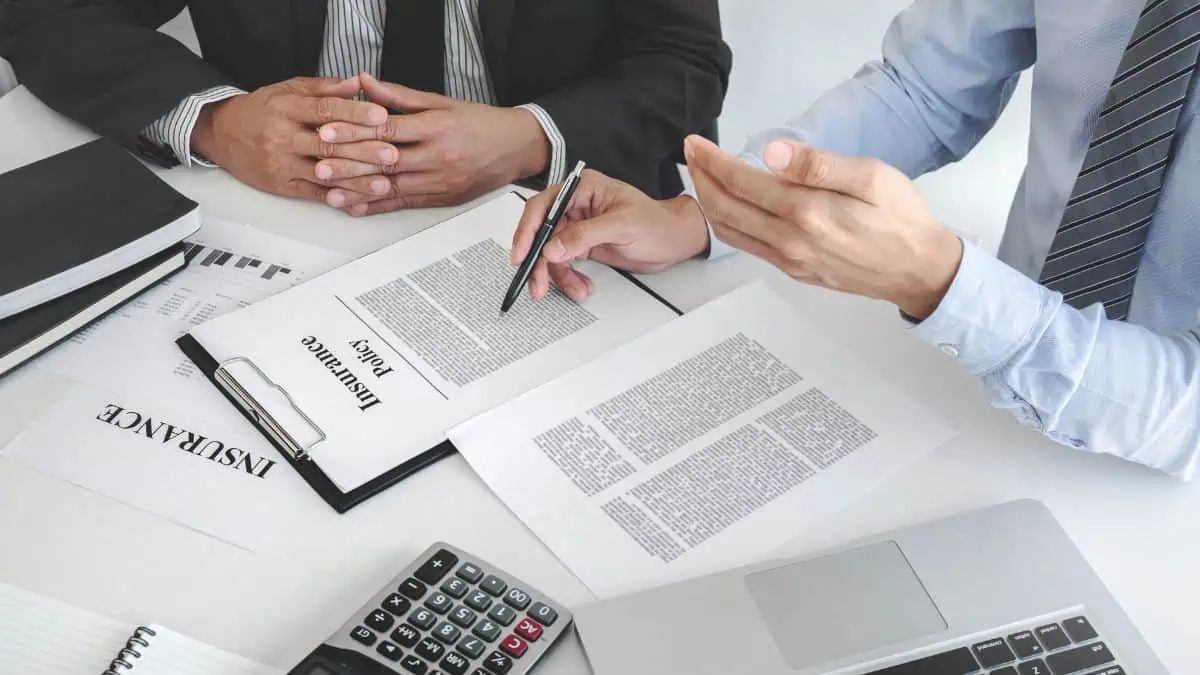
[0,244,187,376]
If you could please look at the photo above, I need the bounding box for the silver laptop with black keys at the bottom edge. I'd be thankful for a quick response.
[575,501,1166,675]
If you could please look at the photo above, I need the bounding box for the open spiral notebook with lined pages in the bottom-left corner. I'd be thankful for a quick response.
[0,584,282,675]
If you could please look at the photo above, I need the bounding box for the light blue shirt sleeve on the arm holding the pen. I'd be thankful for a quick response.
[709,0,1037,258]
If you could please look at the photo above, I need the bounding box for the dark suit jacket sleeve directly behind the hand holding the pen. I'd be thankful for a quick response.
[533,0,732,197]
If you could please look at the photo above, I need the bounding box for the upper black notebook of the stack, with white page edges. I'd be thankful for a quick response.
[0,139,200,319]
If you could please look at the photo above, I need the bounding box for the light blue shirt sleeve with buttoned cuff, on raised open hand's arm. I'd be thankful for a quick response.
[912,244,1200,478]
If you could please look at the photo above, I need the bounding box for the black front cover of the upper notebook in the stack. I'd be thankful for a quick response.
[0,138,197,295]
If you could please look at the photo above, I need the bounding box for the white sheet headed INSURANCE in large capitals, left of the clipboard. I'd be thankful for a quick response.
[0,382,337,551]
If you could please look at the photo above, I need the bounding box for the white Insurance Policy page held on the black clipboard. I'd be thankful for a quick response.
[192,193,676,491]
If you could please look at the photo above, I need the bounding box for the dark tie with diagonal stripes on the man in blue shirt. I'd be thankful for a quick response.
[1040,0,1200,321]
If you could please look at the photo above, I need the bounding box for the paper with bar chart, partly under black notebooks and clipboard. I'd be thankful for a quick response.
[34,217,348,419]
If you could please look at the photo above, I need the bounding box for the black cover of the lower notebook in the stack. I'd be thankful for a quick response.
[0,244,187,377]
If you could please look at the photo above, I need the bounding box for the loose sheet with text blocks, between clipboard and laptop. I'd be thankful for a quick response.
[450,282,954,598]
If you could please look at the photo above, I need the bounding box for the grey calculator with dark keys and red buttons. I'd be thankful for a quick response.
[289,542,571,675]
